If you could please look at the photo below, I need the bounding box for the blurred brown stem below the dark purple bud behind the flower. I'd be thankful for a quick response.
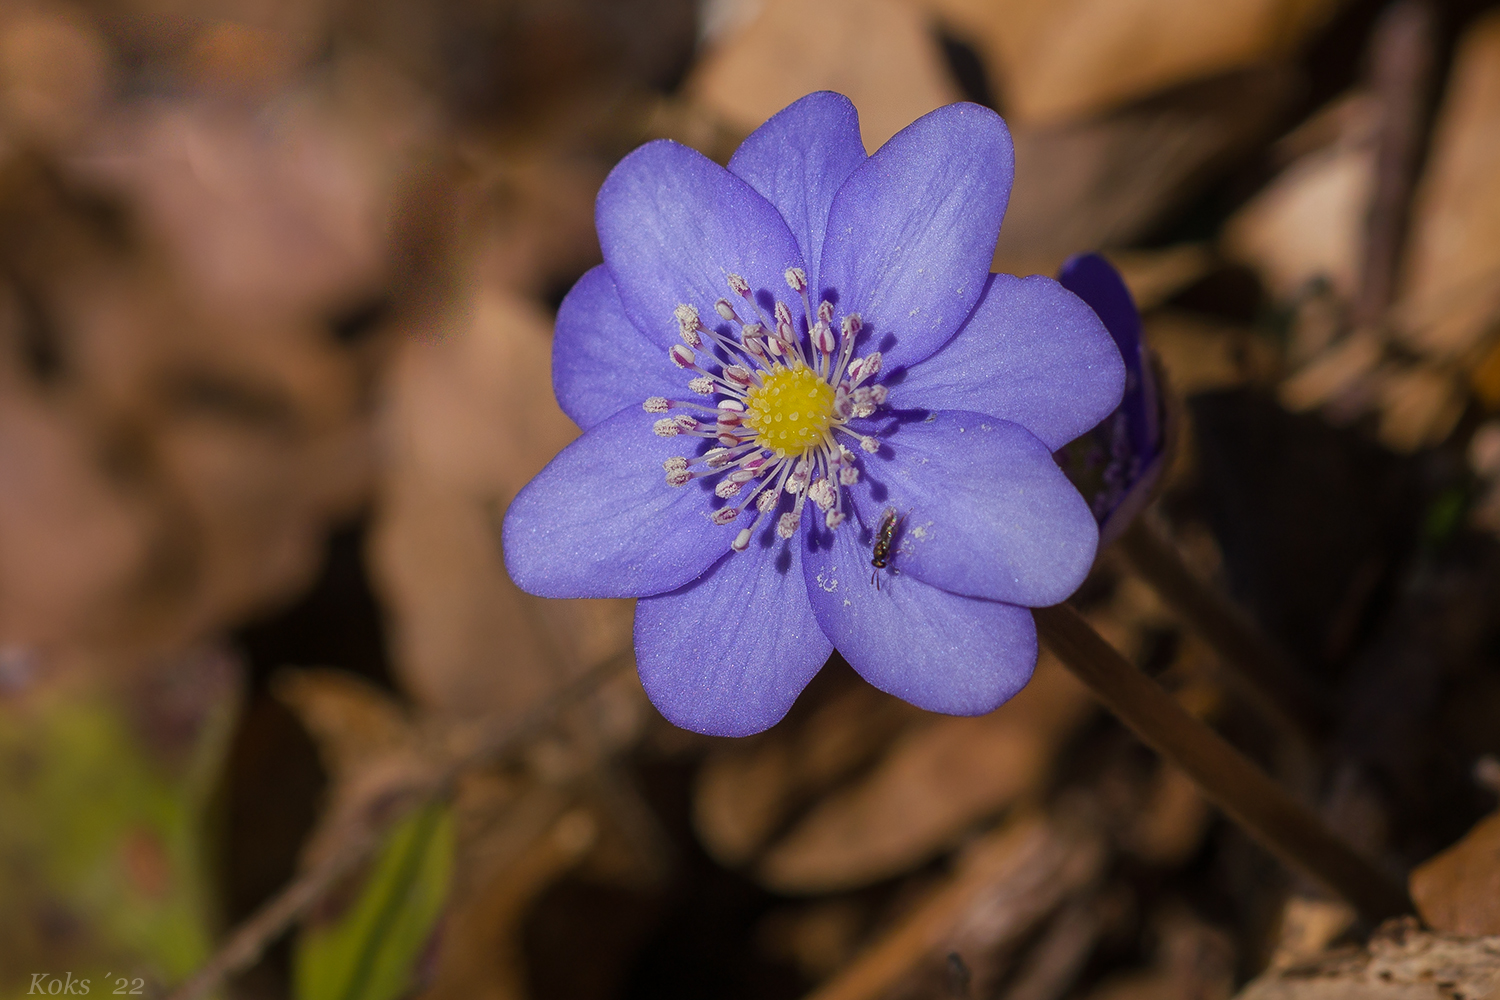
[1119,513,1326,741]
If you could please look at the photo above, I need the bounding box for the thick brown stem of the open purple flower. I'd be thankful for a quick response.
[1034,604,1413,922]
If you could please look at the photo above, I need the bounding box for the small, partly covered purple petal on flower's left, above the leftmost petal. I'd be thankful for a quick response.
[552,264,692,430]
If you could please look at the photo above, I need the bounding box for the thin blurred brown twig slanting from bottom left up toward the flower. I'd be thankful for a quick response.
[167,654,630,1000]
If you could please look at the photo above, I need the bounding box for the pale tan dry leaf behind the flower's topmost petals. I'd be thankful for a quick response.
[687,0,959,150]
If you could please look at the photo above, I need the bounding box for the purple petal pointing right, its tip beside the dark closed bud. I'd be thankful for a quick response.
[891,274,1125,450]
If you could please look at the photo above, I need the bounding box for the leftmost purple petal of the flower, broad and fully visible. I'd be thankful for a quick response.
[504,409,737,597]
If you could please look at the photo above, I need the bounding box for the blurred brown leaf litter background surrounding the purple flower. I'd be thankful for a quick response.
[0,0,1500,1000]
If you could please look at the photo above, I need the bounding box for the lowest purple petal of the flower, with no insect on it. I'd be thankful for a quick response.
[636,531,833,736]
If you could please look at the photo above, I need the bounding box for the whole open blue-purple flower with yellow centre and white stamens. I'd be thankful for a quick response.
[504,93,1125,735]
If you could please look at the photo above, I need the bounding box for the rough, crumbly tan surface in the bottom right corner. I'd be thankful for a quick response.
[1236,919,1500,1000]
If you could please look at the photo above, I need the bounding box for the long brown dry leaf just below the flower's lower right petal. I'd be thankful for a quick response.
[759,655,1091,894]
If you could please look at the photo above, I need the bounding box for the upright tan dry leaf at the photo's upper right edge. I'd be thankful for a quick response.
[1397,13,1500,357]
